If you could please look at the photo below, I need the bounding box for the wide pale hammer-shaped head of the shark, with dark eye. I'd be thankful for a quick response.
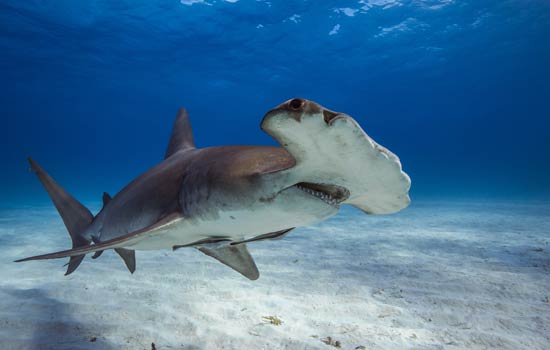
[261,98,411,214]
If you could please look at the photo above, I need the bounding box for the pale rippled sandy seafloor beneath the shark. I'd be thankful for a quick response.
[0,201,550,350]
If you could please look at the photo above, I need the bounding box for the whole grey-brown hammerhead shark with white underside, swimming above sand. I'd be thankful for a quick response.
[17,98,411,280]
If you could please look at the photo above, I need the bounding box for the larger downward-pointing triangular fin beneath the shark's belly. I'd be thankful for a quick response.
[199,244,260,280]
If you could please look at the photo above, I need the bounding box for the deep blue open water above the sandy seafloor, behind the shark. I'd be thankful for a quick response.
[0,0,550,205]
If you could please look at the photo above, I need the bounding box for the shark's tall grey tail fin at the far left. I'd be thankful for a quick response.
[29,157,94,275]
